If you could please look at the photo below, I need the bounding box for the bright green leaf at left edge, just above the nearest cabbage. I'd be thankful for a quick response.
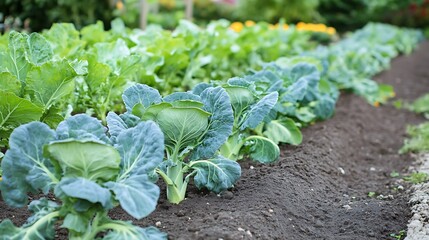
[0,91,43,128]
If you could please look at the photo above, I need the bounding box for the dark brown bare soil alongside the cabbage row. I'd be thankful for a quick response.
[0,42,429,240]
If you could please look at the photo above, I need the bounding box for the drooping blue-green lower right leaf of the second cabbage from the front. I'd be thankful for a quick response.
[189,156,241,193]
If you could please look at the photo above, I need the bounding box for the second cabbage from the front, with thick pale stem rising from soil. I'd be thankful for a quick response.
[107,84,241,203]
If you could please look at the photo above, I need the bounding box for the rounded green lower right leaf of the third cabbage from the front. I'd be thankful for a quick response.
[245,136,280,163]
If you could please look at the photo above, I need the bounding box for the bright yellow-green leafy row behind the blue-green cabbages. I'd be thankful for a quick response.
[0,20,332,146]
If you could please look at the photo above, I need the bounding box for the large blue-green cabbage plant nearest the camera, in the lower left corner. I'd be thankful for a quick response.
[0,115,166,240]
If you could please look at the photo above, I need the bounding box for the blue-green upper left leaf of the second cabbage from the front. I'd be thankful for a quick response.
[122,84,162,112]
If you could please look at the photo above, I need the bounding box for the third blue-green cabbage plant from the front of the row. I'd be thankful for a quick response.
[193,78,280,163]
